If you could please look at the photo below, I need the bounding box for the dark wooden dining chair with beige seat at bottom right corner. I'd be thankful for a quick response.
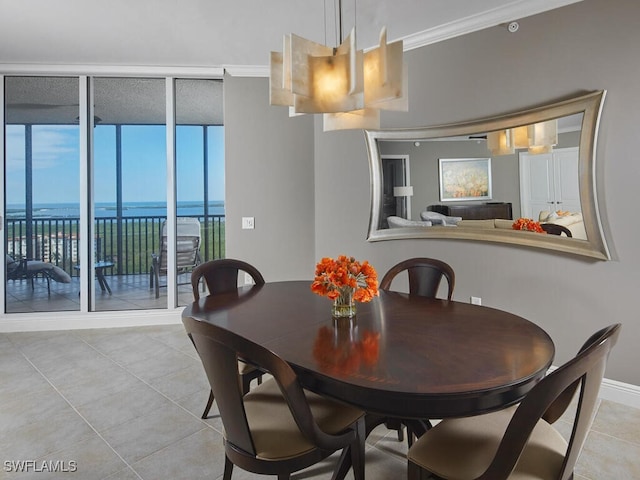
[407,324,621,480]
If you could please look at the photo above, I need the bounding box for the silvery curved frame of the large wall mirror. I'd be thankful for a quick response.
[365,90,610,260]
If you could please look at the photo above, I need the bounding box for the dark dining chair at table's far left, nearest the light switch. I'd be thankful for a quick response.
[191,258,264,419]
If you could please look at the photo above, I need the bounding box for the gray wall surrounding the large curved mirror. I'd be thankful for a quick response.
[308,0,640,385]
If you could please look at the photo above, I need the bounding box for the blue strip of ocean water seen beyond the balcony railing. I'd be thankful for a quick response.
[6,200,224,219]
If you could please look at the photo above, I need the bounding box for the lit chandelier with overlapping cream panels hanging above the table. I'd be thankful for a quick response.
[269,0,409,131]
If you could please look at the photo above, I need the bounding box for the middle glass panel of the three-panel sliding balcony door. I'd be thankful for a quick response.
[93,78,167,310]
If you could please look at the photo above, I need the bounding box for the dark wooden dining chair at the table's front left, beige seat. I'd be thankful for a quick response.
[182,317,365,480]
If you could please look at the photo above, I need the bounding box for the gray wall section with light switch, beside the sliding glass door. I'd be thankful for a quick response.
[224,76,314,281]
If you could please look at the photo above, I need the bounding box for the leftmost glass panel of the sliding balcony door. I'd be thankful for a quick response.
[3,77,81,312]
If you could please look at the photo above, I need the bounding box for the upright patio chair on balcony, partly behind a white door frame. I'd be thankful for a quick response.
[149,217,201,298]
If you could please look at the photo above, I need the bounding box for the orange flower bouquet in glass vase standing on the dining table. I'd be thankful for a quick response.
[311,255,378,318]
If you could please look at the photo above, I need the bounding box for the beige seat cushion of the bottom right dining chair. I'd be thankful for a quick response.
[408,406,567,480]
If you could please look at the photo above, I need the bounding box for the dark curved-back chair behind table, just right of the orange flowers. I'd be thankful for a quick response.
[380,258,456,300]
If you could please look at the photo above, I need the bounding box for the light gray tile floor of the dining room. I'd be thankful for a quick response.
[0,324,640,480]
